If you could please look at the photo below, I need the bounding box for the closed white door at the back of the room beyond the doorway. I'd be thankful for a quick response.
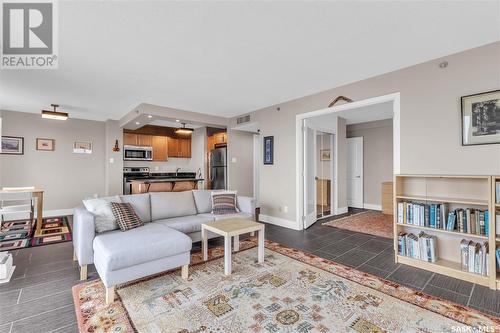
[347,137,363,208]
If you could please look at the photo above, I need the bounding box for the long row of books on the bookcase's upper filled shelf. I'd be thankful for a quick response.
[398,202,489,236]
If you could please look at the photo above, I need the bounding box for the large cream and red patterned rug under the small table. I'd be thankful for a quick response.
[73,240,500,333]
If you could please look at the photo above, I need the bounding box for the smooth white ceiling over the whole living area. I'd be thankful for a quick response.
[0,1,500,120]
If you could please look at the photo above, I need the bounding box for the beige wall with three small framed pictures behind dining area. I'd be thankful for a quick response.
[0,111,107,210]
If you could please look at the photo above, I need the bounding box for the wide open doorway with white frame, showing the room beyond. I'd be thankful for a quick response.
[298,94,399,228]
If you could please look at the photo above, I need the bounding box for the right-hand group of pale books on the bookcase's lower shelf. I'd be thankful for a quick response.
[460,239,489,276]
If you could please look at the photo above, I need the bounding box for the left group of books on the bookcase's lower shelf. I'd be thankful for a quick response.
[398,232,437,262]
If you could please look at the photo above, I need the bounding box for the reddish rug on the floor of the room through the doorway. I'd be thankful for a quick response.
[323,210,394,238]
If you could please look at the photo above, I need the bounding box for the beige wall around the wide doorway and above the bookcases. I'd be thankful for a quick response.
[232,42,500,226]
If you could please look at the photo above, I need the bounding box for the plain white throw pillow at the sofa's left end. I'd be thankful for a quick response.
[83,196,121,233]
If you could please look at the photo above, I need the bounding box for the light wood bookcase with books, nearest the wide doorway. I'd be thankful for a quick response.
[394,175,500,289]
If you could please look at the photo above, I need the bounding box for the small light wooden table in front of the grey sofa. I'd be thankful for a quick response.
[201,219,265,275]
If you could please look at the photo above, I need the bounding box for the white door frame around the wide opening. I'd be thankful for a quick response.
[295,92,401,230]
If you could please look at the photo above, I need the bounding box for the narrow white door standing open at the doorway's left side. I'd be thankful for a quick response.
[303,119,317,229]
